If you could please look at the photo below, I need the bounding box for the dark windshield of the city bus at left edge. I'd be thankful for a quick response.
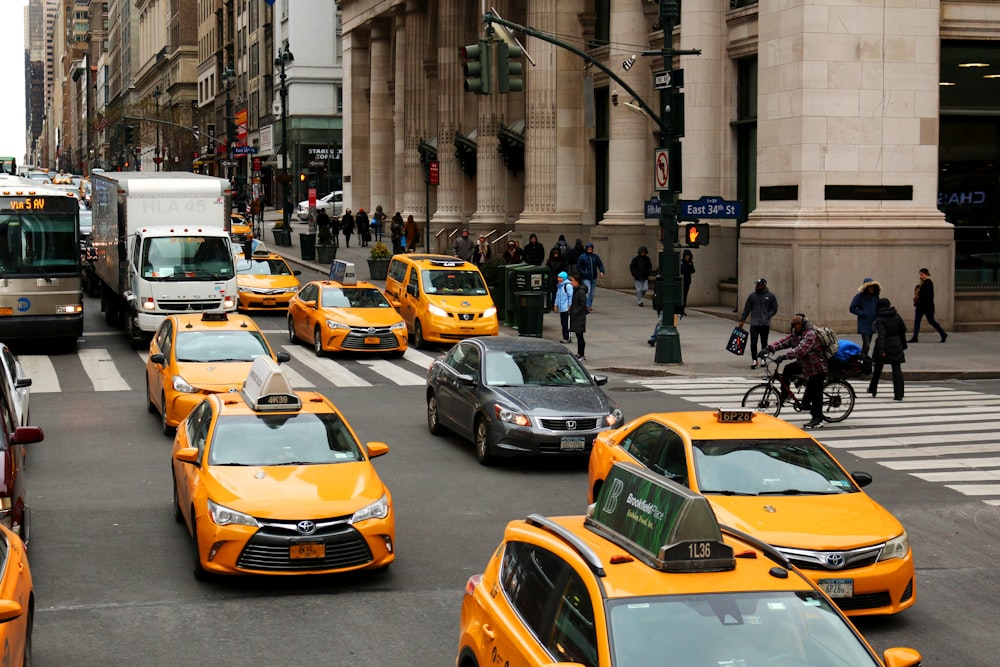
[0,213,80,276]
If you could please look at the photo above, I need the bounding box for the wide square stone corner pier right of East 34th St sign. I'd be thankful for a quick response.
[739,0,954,333]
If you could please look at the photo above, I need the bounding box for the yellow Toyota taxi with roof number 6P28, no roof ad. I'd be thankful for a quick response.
[588,410,916,616]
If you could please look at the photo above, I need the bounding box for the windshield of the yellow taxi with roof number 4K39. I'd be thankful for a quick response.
[208,412,364,466]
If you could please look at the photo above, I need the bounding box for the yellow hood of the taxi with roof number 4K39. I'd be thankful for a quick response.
[206,461,386,519]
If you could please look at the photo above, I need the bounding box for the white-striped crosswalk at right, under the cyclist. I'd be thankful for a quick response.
[633,377,1000,506]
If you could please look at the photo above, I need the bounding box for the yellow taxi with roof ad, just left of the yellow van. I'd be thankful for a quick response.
[288,260,407,356]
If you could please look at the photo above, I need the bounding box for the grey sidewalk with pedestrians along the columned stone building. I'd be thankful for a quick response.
[261,210,1000,382]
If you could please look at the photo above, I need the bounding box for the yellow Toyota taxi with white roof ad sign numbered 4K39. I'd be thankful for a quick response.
[171,356,396,579]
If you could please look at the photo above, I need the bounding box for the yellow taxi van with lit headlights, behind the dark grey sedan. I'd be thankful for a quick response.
[385,254,500,348]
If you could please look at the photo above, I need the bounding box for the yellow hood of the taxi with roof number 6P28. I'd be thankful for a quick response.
[708,492,903,551]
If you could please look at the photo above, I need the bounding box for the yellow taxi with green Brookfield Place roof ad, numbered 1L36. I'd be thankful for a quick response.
[455,464,920,667]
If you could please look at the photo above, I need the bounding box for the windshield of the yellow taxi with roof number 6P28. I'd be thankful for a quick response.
[692,438,857,496]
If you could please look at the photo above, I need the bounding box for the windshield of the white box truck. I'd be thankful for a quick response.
[140,236,235,280]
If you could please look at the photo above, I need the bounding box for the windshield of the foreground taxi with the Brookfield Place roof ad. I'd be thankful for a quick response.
[607,592,880,667]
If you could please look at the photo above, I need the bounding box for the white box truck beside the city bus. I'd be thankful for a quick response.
[91,171,237,346]
